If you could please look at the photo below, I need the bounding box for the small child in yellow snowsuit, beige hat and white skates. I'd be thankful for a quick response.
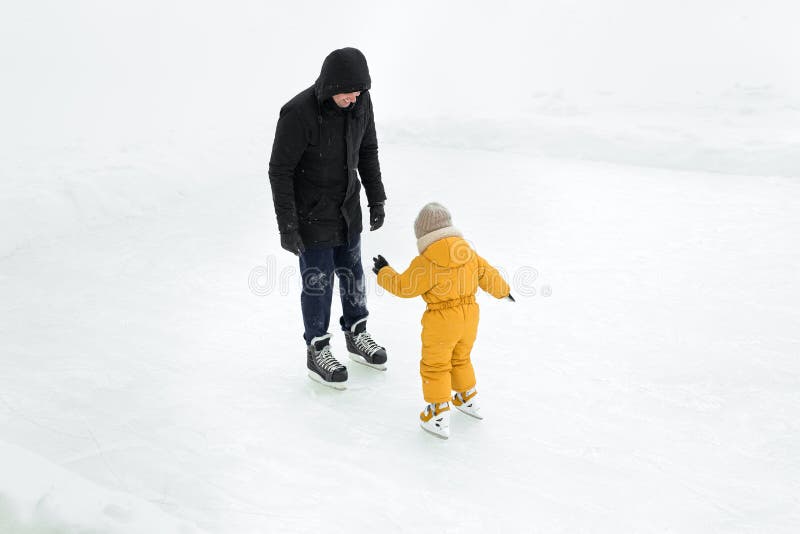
[372,202,514,439]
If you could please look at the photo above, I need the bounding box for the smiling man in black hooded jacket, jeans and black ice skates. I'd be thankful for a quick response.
[269,48,386,389]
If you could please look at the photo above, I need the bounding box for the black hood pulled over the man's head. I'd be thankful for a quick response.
[314,48,372,102]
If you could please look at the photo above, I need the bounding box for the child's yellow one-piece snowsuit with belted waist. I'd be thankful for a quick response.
[378,237,510,403]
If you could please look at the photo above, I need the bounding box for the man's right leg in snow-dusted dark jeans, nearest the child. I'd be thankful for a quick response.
[333,235,369,332]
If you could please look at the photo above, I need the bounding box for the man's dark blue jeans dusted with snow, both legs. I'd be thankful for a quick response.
[300,234,368,344]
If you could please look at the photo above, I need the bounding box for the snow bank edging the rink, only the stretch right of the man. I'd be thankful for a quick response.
[380,86,800,176]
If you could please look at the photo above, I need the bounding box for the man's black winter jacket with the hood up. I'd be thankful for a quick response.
[269,48,386,247]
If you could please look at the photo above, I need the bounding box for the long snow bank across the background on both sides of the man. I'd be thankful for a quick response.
[0,92,800,264]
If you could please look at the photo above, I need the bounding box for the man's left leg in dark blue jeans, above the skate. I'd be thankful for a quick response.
[300,247,334,344]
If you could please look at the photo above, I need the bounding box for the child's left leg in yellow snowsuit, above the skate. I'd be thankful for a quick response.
[419,310,458,403]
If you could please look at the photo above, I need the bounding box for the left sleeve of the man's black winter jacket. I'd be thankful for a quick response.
[269,110,308,233]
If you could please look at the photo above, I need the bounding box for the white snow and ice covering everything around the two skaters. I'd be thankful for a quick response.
[0,1,800,534]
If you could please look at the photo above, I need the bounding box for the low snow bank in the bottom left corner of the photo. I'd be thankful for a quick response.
[0,441,198,534]
